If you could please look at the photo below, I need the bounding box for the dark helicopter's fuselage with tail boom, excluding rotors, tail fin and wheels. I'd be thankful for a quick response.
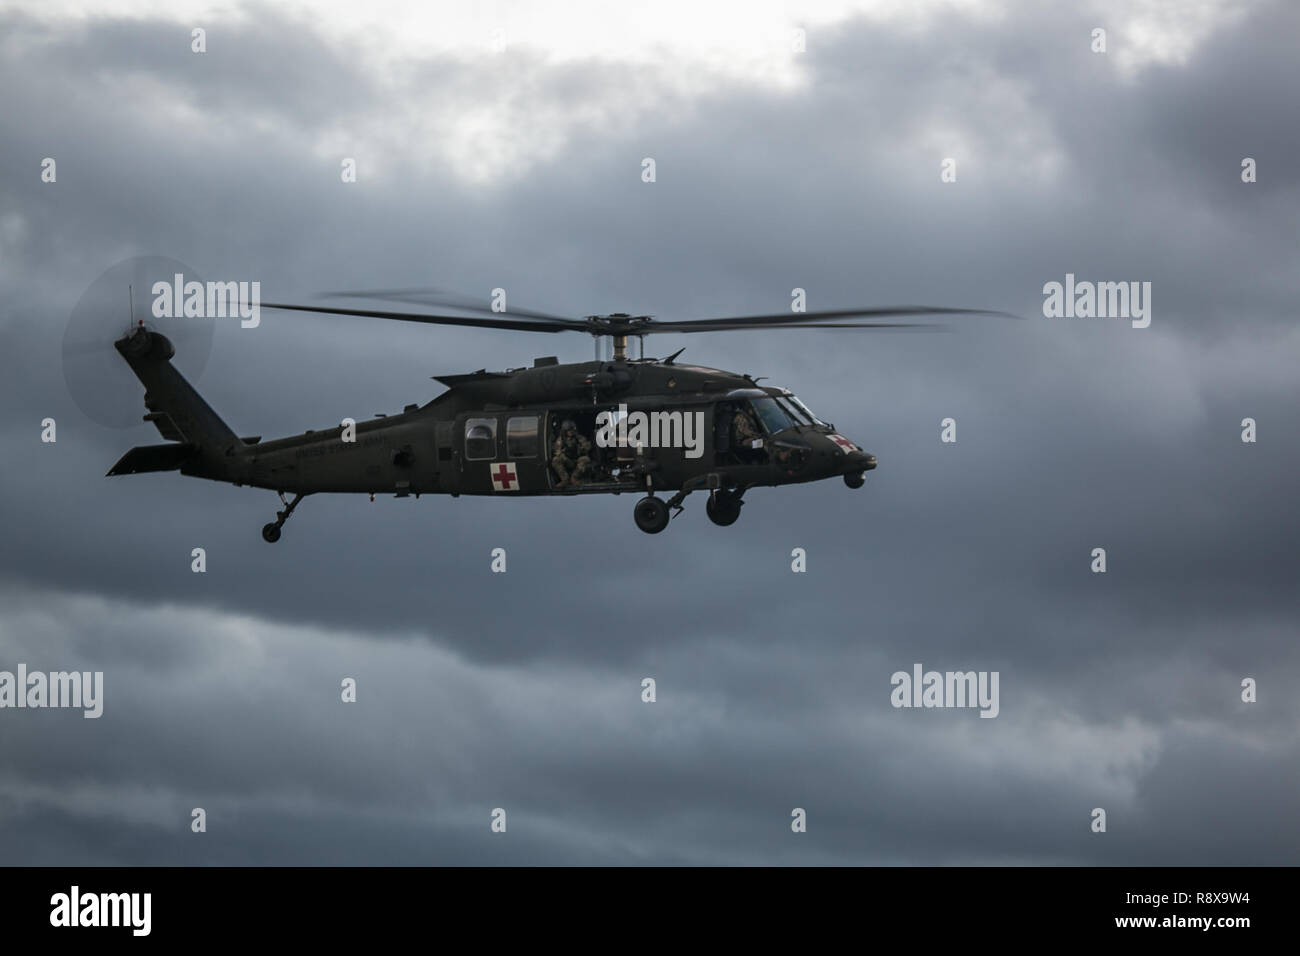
[220,362,875,497]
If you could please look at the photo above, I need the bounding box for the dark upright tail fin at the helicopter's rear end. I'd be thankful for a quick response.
[109,326,242,463]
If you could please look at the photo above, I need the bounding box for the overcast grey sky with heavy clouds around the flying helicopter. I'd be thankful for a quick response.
[0,0,1300,865]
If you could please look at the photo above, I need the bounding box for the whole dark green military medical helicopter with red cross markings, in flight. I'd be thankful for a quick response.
[108,290,992,542]
